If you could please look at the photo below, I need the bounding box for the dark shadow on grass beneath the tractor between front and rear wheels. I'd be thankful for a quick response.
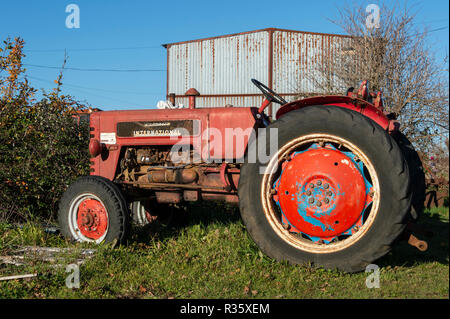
[128,202,241,244]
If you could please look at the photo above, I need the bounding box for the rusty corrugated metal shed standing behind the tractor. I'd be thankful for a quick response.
[164,28,350,114]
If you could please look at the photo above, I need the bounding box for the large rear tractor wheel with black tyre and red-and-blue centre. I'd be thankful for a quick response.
[238,106,411,272]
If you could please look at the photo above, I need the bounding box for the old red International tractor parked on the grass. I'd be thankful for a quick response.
[58,79,426,272]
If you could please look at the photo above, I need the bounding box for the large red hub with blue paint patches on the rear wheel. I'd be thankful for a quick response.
[274,146,367,239]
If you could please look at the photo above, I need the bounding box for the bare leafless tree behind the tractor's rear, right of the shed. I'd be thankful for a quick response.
[304,4,449,153]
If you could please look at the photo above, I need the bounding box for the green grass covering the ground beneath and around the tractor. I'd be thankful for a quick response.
[0,205,449,299]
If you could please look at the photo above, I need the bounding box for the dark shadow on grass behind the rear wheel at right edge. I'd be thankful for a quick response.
[375,213,449,267]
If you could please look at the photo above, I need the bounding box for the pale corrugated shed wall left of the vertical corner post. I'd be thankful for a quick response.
[167,31,269,107]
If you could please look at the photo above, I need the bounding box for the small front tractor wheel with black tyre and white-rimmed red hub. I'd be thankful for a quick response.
[58,176,129,243]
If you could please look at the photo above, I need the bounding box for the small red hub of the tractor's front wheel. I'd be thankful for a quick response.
[77,198,108,240]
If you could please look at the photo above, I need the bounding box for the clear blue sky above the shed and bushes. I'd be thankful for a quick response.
[0,0,449,110]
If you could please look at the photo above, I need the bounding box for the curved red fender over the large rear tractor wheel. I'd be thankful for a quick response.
[276,95,390,132]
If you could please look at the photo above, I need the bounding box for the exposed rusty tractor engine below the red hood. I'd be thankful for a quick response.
[115,145,240,203]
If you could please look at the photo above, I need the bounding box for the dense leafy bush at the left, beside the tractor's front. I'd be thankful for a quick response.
[0,39,89,221]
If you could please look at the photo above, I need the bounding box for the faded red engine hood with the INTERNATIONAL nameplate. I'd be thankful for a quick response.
[90,107,258,179]
